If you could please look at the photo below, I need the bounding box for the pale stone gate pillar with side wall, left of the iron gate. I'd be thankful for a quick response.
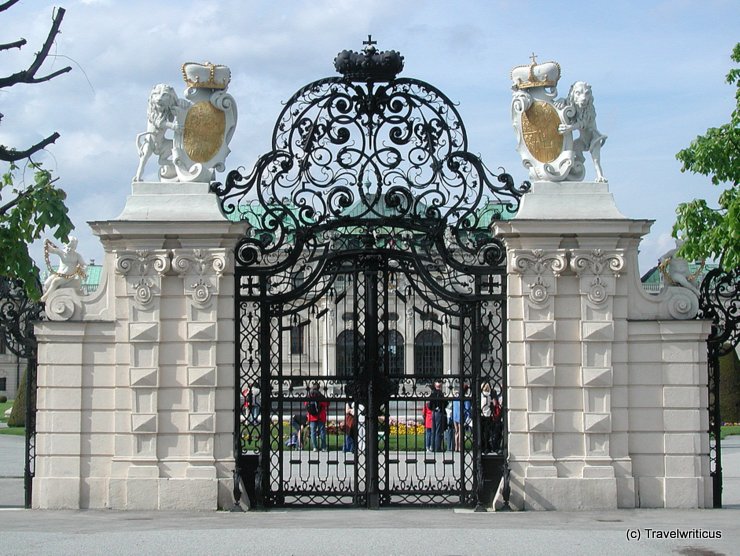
[33,182,244,510]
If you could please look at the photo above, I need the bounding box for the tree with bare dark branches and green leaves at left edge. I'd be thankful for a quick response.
[0,0,74,299]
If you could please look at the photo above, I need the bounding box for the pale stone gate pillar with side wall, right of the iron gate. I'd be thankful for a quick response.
[496,182,711,510]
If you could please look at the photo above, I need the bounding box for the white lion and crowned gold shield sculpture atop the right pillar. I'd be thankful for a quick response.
[511,54,607,182]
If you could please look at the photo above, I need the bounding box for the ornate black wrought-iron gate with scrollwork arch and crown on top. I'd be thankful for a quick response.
[213,41,528,508]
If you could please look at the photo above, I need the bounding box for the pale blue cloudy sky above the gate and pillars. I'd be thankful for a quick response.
[0,0,740,272]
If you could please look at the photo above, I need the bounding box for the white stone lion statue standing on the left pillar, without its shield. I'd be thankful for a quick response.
[134,84,186,181]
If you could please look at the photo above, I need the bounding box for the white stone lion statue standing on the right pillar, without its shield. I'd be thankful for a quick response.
[558,81,607,182]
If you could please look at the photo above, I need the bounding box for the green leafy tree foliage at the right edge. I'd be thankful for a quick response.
[673,43,740,270]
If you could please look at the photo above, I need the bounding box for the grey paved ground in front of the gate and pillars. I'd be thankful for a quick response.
[0,436,740,556]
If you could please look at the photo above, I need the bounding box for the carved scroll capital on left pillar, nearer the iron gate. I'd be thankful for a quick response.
[172,249,232,308]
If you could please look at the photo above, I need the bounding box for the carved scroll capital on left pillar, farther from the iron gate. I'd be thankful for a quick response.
[115,250,170,310]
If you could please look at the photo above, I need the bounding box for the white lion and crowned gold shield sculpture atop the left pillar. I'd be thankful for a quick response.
[134,62,237,182]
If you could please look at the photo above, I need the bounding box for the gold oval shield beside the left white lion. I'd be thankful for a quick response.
[182,101,226,162]
